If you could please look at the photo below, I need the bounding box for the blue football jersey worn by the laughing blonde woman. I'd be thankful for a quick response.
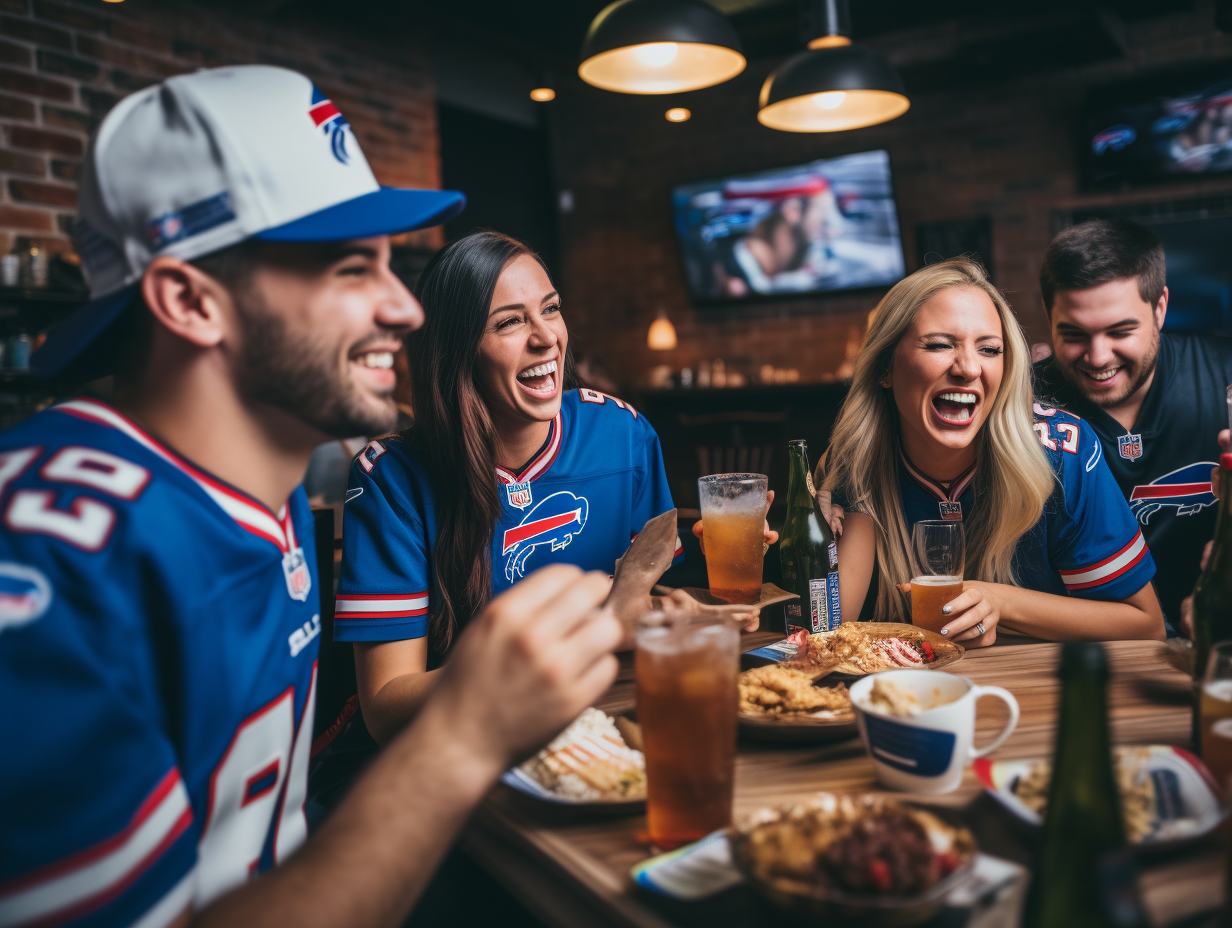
[834,403,1154,600]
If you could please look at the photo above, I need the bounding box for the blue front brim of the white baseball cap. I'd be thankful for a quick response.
[256,187,466,242]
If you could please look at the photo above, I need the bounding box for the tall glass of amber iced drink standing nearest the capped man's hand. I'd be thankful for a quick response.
[634,615,740,848]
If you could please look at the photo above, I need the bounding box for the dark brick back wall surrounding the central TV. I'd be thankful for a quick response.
[551,4,1232,385]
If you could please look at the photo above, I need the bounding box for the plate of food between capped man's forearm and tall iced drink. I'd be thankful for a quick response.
[500,709,646,812]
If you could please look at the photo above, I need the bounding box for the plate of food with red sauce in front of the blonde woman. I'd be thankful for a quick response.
[763,622,966,679]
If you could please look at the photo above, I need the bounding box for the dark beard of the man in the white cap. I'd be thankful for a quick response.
[235,292,398,439]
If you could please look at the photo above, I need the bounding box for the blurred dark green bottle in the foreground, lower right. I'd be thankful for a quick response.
[1023,642,1125,928]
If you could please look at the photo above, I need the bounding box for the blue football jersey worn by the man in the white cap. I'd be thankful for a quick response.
[0,399,320,928]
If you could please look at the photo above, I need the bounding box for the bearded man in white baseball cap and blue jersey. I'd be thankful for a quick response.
[0,67,621,928]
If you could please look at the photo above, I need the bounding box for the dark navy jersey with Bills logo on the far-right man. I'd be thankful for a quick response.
[1035,333,1232,624]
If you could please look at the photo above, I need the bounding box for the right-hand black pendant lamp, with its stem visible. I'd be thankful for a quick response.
[758,0,912,132]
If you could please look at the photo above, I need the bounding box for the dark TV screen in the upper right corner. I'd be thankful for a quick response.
[1084,68,1232,187]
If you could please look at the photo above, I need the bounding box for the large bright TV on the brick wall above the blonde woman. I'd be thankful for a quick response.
[671,152,904,303]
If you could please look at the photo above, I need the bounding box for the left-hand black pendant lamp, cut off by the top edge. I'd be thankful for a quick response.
[578,0,745,94]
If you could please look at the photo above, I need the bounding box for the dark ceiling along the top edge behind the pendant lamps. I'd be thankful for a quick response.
[285,0,1202,92]
